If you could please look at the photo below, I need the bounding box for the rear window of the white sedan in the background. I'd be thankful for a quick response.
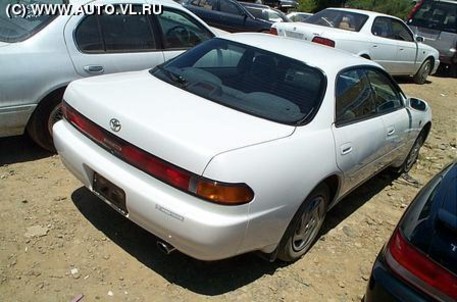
[304,9,368,32]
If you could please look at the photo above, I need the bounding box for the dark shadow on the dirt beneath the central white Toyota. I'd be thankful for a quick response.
[71,173,393,296]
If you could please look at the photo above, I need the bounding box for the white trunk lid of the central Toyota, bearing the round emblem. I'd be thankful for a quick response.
[64,70,295,175]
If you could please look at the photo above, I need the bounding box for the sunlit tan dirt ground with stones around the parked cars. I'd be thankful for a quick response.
[0,73,457,302]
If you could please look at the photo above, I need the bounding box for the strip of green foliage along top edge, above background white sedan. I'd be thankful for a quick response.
[299,0,413,19]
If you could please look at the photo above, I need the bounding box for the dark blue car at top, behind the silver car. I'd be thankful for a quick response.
[183,0,273,32]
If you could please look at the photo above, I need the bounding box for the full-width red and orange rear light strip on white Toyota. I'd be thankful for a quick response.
[62,102,254,205]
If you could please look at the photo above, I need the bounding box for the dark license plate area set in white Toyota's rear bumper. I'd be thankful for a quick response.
[92,173,128,215]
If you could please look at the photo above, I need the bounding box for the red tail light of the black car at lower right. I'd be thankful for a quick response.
[386,228,457,301]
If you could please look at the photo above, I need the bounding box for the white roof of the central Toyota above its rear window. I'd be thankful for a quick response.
[219,33,382,71]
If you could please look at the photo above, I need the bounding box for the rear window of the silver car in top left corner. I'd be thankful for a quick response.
[0,0,68,43]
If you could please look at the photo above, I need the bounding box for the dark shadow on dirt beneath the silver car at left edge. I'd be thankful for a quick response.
[0,135,52,166]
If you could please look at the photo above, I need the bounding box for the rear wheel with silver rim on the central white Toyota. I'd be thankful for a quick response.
[278,184,330,262]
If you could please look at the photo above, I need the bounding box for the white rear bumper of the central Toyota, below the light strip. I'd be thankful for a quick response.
[53,121,253,260]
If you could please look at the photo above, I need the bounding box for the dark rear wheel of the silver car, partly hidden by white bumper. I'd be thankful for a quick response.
[27,89,64,153]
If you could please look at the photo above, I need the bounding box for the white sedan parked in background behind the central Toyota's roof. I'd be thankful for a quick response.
[271,8,440,84]
